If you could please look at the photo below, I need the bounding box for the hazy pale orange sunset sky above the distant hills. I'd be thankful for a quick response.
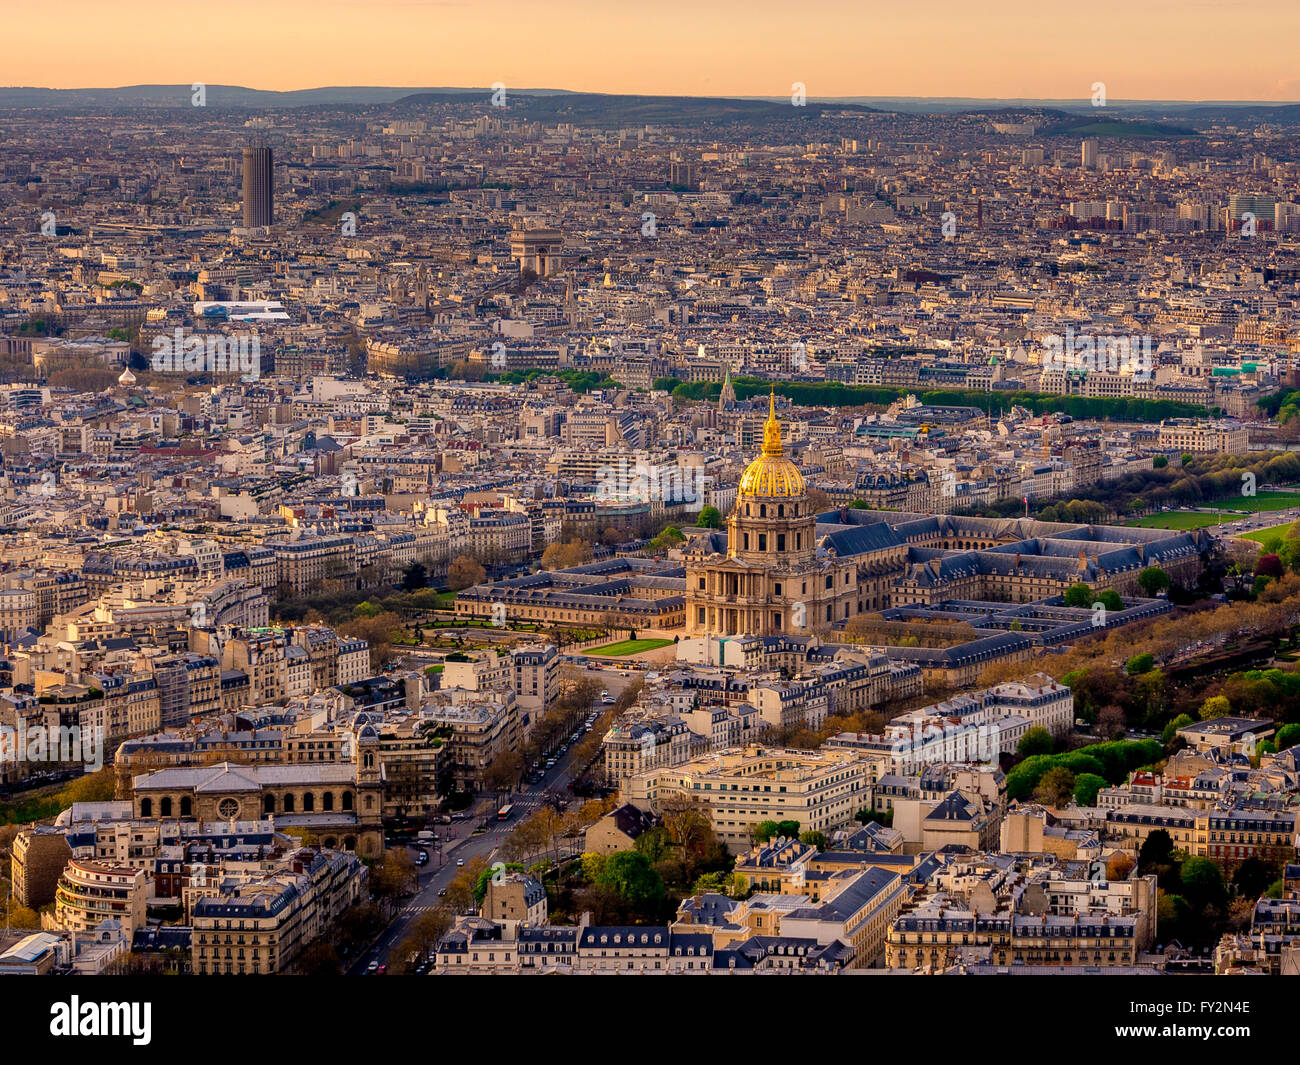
[10,0,1300,101]
